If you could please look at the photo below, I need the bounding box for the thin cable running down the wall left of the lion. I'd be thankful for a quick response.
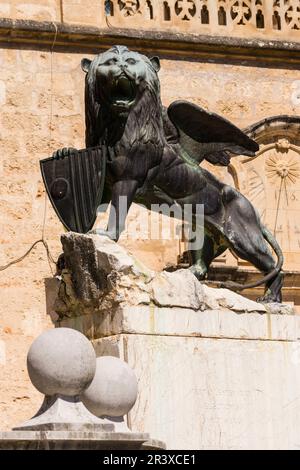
[0,23,58,275]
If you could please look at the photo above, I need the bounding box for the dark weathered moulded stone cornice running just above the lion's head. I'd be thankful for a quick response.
[0,18,300,66]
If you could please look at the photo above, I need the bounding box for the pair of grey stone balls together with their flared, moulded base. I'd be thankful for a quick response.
[11,328,165,450]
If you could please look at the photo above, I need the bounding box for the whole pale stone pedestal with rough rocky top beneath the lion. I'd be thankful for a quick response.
[48,234,300,449]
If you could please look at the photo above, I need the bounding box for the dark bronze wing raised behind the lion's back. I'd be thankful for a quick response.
[168,101,259,166]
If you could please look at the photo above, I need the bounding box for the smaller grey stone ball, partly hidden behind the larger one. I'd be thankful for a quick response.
[81,356,137,417]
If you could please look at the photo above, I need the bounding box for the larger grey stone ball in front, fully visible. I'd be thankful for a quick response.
[27,328,96,396]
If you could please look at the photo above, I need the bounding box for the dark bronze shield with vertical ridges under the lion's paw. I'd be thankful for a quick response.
[40,147,106,233]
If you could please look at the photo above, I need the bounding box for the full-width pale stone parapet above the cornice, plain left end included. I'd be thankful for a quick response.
[0,0,300,42]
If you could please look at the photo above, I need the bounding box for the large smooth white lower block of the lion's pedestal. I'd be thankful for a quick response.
[95,332,300,450]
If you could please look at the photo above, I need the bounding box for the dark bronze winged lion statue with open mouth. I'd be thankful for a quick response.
[44,46,283,302]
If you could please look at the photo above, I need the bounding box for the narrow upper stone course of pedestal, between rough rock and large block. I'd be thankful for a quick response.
[59,305,300,341]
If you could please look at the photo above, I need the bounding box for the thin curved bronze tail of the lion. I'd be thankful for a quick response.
[214,225,284,291]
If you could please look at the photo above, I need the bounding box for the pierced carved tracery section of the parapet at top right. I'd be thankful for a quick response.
[104,0,300,41]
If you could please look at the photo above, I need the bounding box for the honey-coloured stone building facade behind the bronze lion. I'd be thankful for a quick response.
[0,0,300,429]
